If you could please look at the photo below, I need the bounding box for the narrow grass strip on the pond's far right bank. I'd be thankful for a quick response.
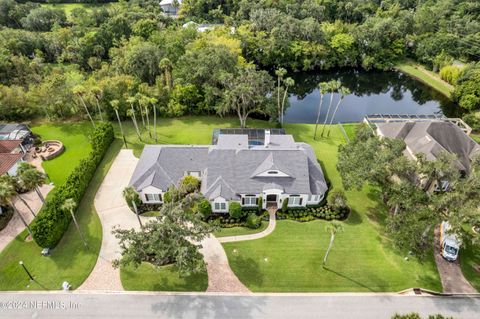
[396,61,454,98]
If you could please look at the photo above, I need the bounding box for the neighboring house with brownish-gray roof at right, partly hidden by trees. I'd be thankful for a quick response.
[375,121,480,191]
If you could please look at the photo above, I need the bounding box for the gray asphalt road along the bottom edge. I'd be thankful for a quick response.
[0,293,480,319]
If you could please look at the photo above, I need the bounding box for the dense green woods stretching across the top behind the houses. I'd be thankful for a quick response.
[0,0,480,126]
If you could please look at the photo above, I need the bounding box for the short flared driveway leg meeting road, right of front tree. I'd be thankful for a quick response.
[200,235,250,294]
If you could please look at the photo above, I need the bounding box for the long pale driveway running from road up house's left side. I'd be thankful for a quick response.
[78,149,145,291]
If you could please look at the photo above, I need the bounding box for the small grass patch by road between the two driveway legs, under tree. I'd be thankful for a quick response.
[120,263,208,291]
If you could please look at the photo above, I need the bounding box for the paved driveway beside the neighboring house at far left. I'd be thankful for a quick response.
[0,185,53,251]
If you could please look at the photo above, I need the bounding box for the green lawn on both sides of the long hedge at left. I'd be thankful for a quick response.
[0,127,122,290]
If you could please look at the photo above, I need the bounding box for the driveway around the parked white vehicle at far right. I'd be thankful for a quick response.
[434,227,477,294]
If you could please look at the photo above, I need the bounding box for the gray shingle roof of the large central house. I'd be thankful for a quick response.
[130,135,327,200]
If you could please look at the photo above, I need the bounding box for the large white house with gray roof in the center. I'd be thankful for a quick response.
[130,129,327,213]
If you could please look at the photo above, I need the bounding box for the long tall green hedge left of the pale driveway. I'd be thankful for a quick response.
[31,123,114,248]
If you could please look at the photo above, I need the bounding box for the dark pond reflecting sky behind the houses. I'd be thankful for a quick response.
[285,69,458,123]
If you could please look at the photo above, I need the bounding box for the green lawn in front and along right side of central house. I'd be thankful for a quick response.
[224,124,441,292]
